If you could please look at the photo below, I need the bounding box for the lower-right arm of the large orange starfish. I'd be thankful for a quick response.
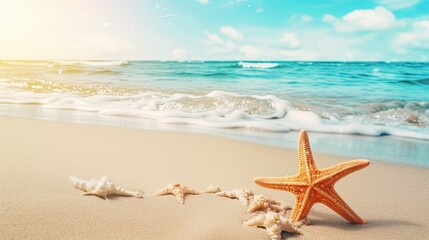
[315,188,365,224]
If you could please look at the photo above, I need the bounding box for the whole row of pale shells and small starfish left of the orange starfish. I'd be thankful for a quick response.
[70,176,302,240]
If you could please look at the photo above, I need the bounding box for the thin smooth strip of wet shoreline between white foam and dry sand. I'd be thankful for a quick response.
[0,104,429,168]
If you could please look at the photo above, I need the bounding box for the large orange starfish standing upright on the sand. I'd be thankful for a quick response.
[254,130,369,224]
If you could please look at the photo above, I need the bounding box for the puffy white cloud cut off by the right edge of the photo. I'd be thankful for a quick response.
[392,20,429,53]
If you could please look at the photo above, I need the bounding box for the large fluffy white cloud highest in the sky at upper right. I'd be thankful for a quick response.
[323,6,399,32]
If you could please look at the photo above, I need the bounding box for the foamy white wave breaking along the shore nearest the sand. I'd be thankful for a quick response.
[0,84,429,140]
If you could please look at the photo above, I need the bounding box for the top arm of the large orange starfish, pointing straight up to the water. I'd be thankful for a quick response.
[298,129,317,181]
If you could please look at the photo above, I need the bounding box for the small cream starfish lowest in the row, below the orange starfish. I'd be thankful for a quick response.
[243,212,301,240]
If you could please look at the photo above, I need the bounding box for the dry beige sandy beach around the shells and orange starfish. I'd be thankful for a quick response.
[0,117,429,239]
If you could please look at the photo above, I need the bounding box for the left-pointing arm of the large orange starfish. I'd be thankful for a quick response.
[253,176,308,194]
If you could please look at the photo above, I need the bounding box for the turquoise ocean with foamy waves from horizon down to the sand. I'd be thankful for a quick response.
[0,61,429,166]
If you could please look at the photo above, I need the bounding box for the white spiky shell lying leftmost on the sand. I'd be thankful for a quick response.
[70,176,143,200]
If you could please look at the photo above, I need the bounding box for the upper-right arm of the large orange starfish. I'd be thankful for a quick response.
[317,159,370,186]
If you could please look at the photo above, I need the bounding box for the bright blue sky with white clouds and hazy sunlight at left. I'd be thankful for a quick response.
[0,0,429,61]
